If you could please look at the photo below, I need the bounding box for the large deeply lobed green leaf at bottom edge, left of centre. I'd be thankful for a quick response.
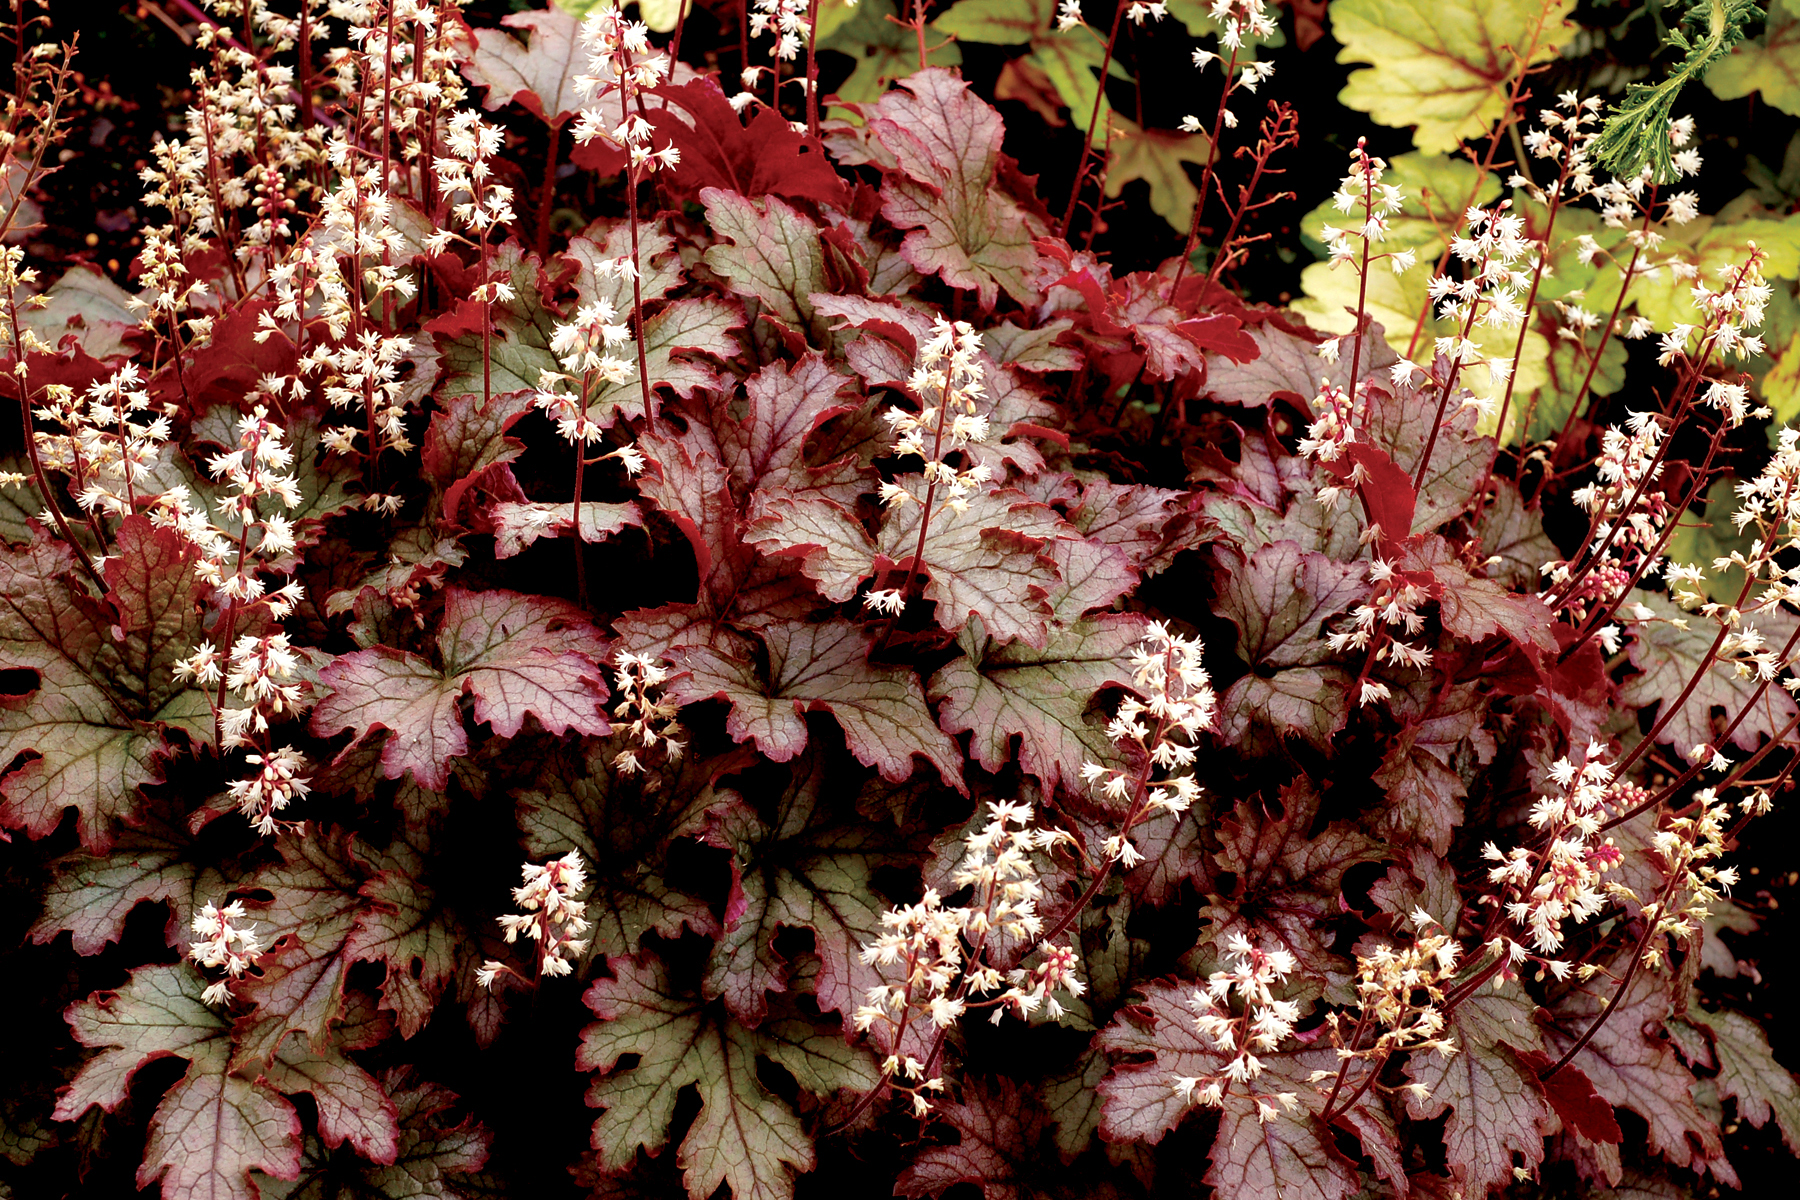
[576,955,880,1200]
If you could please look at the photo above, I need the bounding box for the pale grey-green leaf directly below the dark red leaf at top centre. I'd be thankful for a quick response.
[700,188,832,347]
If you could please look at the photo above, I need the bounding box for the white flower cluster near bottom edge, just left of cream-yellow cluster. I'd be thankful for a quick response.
[1172,934,1300,1121]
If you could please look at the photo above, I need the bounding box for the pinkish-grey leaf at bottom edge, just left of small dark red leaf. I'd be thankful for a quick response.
[1406,988,1555,1195]
